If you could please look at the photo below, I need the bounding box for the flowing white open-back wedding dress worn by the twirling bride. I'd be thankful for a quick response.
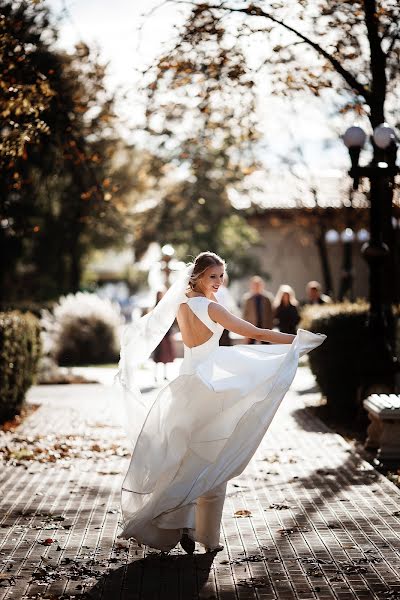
[120,296,326,550]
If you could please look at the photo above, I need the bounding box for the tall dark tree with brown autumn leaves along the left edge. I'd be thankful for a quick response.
[0,0,134,299]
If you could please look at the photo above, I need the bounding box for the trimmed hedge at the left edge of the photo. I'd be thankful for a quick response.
[0,311,41,423]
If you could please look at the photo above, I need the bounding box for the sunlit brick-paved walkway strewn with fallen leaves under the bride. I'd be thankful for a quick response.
[0,360,400,600]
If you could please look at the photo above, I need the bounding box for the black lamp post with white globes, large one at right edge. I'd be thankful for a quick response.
[343,123,398,396]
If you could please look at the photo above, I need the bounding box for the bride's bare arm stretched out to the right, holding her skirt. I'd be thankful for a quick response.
[208,302,296,344]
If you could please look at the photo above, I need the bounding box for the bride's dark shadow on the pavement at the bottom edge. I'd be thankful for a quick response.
[84,553,215,600]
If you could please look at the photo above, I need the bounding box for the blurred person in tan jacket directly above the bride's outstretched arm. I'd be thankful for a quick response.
[243,275,274,344]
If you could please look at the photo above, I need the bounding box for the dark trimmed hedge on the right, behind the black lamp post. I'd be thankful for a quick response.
[300,301,400,416]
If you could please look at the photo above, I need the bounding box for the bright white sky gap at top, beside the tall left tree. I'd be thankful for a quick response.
[47,0,188,130]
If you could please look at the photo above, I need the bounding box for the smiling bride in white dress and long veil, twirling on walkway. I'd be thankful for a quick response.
[118,252,326,554]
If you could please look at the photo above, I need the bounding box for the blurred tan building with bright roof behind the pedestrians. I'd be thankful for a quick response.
[237,176,400,300]
